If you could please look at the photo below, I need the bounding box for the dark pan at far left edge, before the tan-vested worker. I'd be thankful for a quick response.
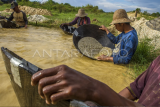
[0,19,17,28]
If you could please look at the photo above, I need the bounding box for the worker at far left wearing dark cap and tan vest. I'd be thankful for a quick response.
[8,1,28,28]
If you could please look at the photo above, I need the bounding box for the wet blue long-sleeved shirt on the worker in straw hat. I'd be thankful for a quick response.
[107,29,138,64]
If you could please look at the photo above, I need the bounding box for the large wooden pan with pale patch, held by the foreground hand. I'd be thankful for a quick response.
[1,47,70,107]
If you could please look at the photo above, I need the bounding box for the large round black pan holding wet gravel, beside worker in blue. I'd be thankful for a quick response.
[73,24,115,59]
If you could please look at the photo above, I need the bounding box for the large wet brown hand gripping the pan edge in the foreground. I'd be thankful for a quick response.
[31,65,98,104]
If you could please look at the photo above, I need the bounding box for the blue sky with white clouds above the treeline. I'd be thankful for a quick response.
[35,0,160,13]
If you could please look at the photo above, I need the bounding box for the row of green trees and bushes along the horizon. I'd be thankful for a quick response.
[18,0,104,13]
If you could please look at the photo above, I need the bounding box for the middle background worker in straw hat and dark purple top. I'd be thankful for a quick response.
[62,9,90,27]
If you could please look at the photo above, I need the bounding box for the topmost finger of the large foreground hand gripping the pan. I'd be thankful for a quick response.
[31,66,61,86]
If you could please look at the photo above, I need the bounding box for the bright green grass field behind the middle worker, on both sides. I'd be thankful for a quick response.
[29,12,113,28]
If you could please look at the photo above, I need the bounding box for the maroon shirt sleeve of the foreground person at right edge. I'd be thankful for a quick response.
[127,56,160,107]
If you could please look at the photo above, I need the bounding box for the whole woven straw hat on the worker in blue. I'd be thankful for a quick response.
[111,9,132,24]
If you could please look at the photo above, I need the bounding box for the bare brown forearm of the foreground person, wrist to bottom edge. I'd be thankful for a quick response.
[91,81,142,107]
